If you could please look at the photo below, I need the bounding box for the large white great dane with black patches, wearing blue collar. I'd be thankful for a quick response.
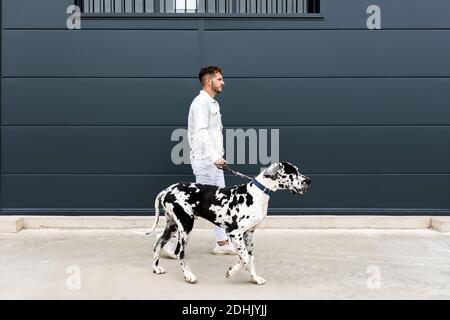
[150,162,311,284]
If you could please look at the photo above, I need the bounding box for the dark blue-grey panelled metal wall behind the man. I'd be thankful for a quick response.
[1,0,450,214]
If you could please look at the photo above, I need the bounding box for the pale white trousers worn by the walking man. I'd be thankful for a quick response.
[191,159,228,241]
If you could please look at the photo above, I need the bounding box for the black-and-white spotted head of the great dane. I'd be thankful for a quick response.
[263,161,311,195]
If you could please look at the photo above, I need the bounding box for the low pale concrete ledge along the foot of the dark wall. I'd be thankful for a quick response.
[0,215,450,232]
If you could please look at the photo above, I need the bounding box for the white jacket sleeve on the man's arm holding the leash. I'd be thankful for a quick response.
[193,101,222,163]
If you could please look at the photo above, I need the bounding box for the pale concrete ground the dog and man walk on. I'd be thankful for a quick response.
[0,229,450,300]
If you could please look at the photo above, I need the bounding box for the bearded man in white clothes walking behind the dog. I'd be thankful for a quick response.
[165,66,236,257]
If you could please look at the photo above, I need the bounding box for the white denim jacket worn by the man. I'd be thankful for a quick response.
[188,90,225,162]
